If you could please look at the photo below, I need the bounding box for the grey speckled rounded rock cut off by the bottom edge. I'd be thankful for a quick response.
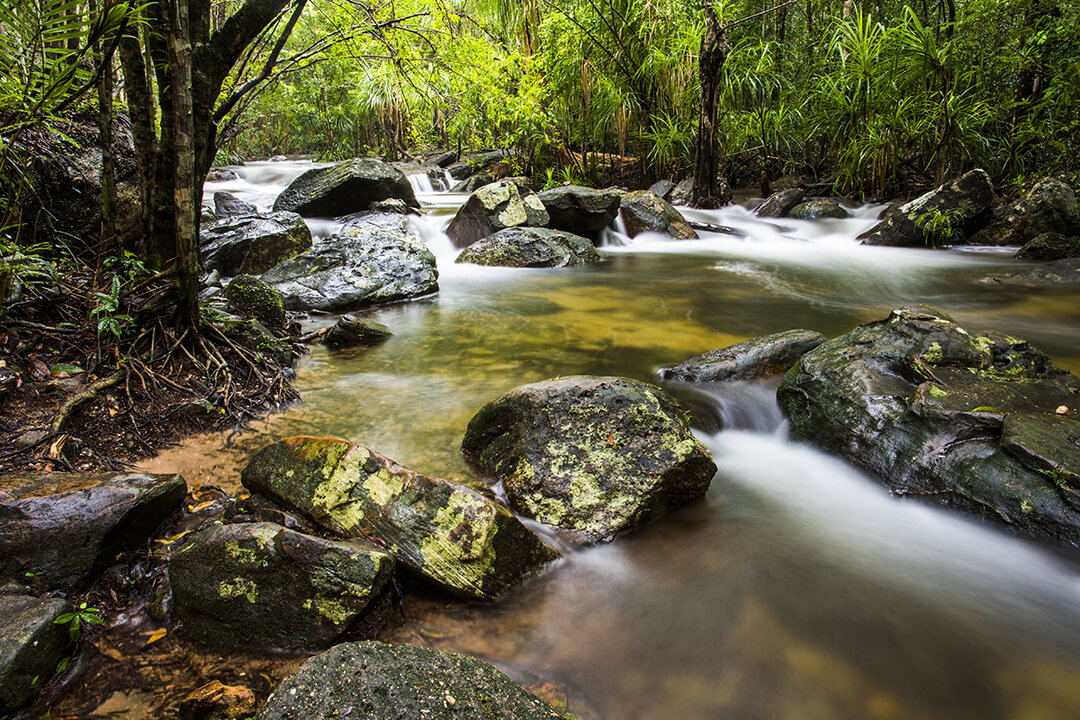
[258,641,563,720]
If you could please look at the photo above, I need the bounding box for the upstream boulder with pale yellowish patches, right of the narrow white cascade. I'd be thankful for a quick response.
[446,180,550,247]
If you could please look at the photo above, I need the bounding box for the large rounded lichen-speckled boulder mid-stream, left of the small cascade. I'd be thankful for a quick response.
[461,376,716,542]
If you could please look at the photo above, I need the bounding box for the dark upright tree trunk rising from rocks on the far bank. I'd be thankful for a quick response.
[692,2,731,207]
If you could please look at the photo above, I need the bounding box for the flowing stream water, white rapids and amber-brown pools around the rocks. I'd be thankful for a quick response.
[154,163,1080,720]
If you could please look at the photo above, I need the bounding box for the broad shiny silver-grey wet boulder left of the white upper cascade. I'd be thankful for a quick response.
[262,213,438,312]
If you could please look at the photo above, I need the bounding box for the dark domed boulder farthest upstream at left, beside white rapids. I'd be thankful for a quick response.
[273,158,419,217]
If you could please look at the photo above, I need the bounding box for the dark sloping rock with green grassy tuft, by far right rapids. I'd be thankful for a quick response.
[859,168,994,247]
